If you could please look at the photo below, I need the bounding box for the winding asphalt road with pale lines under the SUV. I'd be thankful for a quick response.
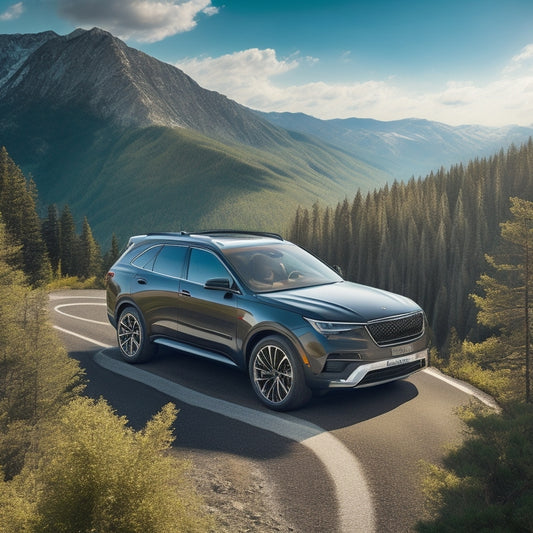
[47,291,492,533]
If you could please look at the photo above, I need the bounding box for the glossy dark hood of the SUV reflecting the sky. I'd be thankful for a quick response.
[258,281,421,323]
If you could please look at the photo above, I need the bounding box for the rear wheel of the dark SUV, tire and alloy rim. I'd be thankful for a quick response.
[117,306,156,363]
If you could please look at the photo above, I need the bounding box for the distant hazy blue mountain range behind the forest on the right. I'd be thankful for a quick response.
[257,112,533,180]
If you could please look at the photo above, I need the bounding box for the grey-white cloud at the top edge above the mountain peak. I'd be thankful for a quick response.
[56,0,218,42]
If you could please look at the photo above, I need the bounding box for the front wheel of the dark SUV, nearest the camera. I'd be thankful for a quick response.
[248,335,311,411]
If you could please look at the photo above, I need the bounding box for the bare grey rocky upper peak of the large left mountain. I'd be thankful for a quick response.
[0,28,277,145]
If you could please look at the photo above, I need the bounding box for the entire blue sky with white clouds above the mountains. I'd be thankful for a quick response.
[0,0,533,126]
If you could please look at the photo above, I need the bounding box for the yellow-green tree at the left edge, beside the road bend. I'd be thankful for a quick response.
[0,218,81,477]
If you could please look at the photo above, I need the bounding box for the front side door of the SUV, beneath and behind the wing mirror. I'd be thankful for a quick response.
[178,248,238,360]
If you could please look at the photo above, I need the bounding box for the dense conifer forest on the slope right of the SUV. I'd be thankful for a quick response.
[290,139,533,351]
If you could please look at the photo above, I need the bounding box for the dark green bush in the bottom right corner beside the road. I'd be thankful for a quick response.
[417,404,533,533]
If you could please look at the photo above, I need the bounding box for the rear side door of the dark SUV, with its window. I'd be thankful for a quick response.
[132,245,188,338]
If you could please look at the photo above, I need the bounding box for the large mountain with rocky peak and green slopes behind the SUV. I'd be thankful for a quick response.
[0,28,388,241]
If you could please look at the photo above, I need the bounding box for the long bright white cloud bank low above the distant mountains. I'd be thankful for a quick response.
[177,45,533,126]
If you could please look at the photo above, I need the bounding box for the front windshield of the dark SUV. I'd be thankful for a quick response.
[223,243,342,292]
